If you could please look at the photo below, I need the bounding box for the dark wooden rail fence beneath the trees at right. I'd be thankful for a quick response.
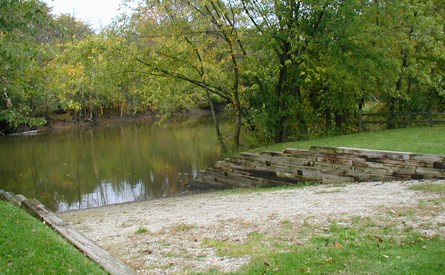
[359,111,445,132]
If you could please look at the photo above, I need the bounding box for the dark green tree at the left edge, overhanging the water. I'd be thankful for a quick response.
[0,0,49,132]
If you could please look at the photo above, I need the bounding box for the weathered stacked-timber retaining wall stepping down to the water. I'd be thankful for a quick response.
[190,146,445,189]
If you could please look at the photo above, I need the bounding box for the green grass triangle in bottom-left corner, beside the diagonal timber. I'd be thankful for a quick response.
[0,201,106,274]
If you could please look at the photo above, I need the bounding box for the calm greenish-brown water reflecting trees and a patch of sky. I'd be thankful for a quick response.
[0,118,220,211]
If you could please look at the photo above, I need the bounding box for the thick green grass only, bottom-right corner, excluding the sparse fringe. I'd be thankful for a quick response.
[239,225,445,274]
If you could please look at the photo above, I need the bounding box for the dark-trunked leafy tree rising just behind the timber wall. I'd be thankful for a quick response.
[241,0,358,142]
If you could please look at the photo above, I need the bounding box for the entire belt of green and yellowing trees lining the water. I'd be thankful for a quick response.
[0,0,445,150]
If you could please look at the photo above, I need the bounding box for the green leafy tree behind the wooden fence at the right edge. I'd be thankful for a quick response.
[364,0,445,128]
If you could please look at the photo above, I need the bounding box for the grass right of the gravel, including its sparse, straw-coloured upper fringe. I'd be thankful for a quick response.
[204,183,445,274]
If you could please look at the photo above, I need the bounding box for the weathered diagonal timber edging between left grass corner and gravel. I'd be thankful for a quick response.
[0,190,136,275]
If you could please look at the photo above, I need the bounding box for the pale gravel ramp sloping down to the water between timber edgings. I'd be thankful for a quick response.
[59,181,445,274]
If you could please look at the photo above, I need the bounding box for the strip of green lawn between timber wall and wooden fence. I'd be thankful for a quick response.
[254,125,445,155]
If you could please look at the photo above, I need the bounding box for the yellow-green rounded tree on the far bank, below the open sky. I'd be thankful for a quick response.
[49,32,138,121]
